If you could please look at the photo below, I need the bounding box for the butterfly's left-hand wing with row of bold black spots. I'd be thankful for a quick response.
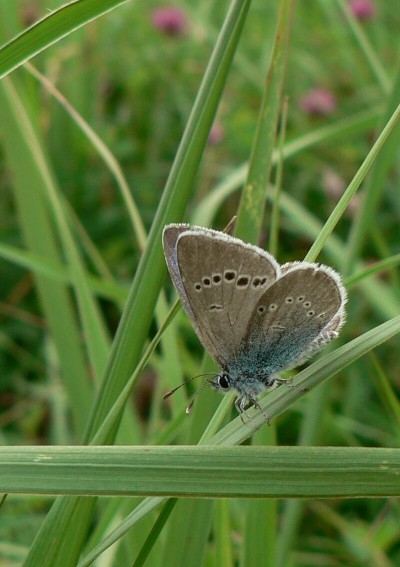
[164,225,280,367]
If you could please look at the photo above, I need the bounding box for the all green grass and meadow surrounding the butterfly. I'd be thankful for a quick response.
[0,0,400,567]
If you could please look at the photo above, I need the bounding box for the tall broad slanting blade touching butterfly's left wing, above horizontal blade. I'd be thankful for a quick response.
[88,0,253,444]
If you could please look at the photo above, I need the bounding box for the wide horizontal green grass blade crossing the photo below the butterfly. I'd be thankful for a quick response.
[0,445,400,500]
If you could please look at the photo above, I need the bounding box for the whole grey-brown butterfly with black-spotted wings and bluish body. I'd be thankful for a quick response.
[163,224,347,413]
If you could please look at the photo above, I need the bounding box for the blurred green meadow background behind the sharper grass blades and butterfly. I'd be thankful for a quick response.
[0,0,400,567]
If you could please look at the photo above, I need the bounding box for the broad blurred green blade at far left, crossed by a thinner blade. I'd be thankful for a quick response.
[0,80,92,432]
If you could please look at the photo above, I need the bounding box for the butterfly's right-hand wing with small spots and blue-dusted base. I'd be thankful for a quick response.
[243,263,343,373]
